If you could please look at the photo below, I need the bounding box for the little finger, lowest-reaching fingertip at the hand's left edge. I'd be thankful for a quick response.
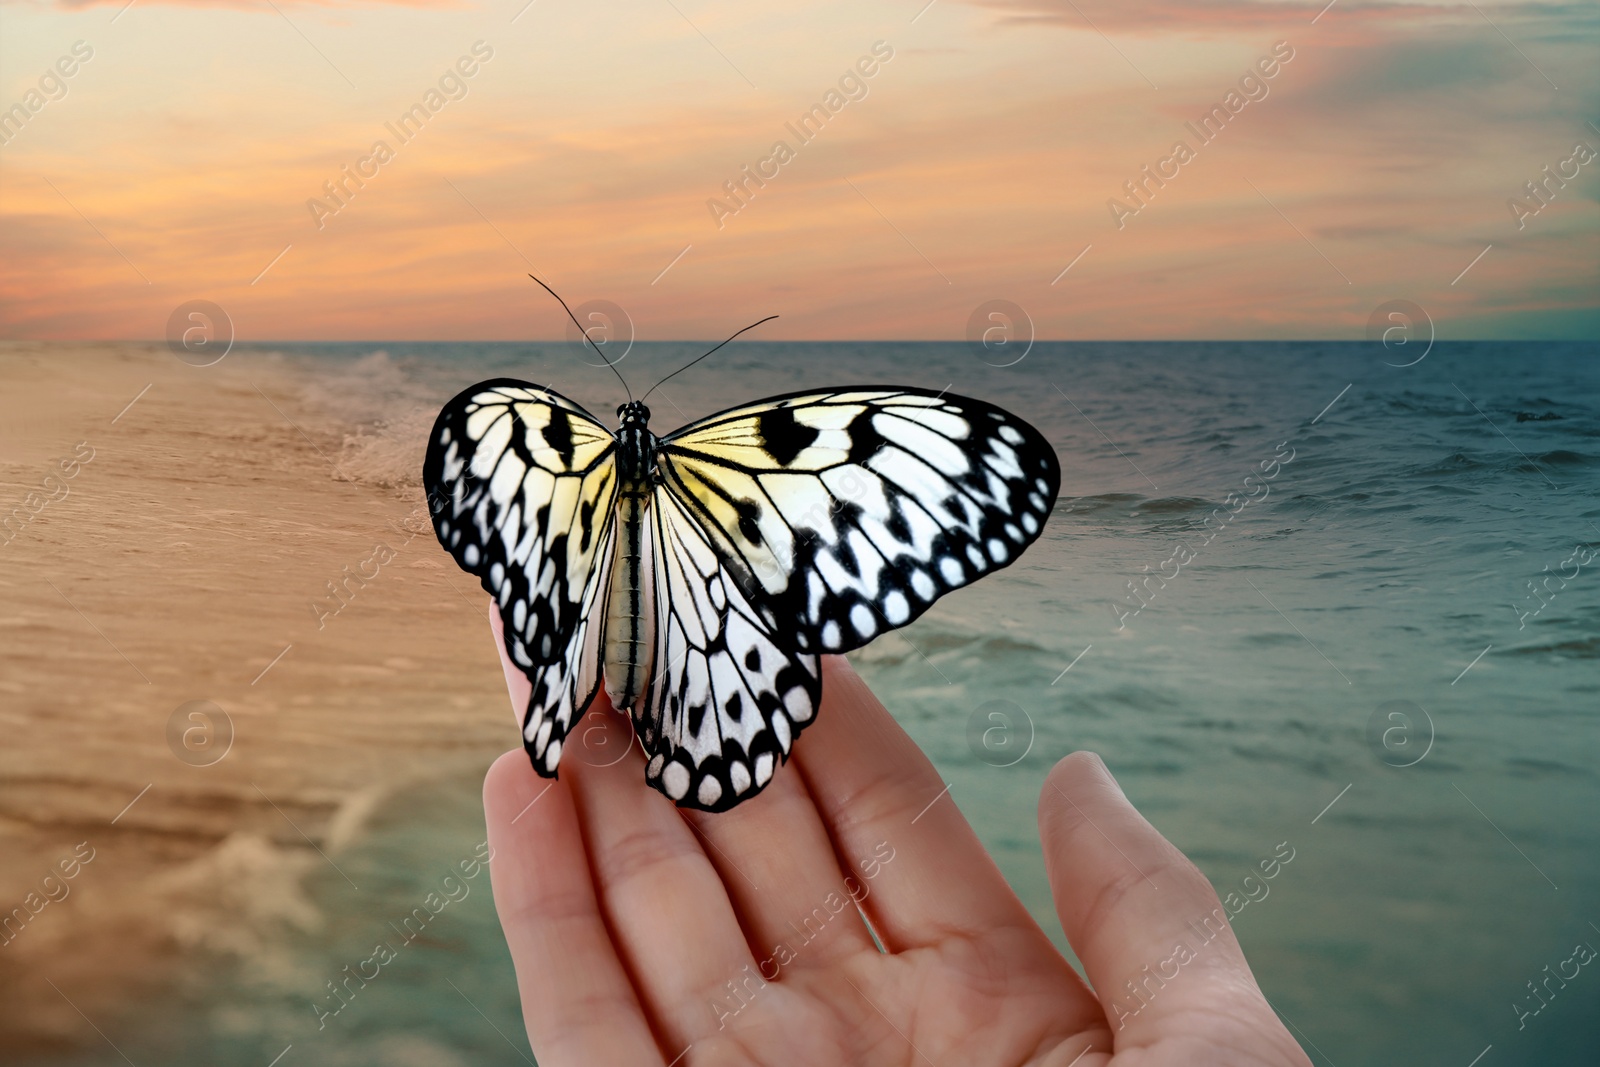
[483,749,664,1067]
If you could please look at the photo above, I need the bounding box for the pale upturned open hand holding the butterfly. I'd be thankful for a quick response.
[483,611,1310,1067]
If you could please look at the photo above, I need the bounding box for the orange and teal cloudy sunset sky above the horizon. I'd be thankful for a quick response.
[0,0,1600,341]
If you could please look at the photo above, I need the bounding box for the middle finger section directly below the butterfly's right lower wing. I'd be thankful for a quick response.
[683,755,875,981]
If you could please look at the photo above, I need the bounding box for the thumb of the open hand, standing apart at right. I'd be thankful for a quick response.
[1038,752,1299,1062]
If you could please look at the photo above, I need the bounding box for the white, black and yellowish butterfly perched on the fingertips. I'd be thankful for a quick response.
[422,278,1061,811]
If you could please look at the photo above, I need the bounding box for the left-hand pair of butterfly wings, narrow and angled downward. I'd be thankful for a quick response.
[422,378,618,777]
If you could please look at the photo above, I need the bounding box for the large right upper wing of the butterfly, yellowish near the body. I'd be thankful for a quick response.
[656,386,1061,654]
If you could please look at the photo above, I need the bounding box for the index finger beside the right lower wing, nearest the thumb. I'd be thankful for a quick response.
[794,656,1043,952]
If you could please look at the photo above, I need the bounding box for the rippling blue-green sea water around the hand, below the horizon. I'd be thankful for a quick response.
[37,342,1600,1067]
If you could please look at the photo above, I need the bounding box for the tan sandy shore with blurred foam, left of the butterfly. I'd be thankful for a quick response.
[0,344,515,1054]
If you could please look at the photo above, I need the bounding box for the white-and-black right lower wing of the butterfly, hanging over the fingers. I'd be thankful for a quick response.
[634,486,822,811]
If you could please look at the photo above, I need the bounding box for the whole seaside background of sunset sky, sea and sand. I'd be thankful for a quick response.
[0,0,1600,1067]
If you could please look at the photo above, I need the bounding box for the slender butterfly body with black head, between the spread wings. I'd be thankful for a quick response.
[602,413,656,709]
